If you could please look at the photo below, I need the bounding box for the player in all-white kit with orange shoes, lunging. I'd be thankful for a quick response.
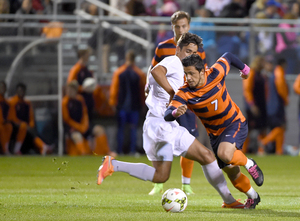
[97,33,244,208]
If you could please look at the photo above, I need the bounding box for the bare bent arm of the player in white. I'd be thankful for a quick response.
[151,65,175,98]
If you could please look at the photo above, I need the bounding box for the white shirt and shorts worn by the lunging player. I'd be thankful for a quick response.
[143,56,195,161]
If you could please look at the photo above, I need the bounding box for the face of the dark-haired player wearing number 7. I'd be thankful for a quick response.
[183,66,205,88]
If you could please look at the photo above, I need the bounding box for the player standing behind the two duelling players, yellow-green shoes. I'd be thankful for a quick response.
[146,11,207,195]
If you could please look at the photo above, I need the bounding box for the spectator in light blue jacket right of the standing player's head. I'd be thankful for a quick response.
[190,7,218,67]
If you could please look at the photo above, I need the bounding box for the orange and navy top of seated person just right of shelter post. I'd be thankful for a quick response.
[62,94,89,133]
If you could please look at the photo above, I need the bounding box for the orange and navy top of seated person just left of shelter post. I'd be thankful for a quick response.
[8,95,35,128]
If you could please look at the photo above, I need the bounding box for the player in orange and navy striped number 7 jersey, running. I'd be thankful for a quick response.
[164,53,264,209]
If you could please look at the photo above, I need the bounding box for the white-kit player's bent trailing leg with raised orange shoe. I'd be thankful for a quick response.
[97,144,173,185]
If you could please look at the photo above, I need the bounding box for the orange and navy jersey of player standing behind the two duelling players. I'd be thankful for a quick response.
[151,38,207,68]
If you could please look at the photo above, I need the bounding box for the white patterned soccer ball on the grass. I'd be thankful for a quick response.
[161,188,187,213]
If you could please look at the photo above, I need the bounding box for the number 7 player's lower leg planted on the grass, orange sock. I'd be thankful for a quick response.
[223,165,260,209]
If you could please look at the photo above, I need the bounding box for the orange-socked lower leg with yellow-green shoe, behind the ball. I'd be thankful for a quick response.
[180,157,194,195]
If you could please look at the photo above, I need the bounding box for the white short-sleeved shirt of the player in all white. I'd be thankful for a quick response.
[146,55,184,117]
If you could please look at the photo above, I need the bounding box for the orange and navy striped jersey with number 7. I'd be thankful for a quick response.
[170,57,246,136]
